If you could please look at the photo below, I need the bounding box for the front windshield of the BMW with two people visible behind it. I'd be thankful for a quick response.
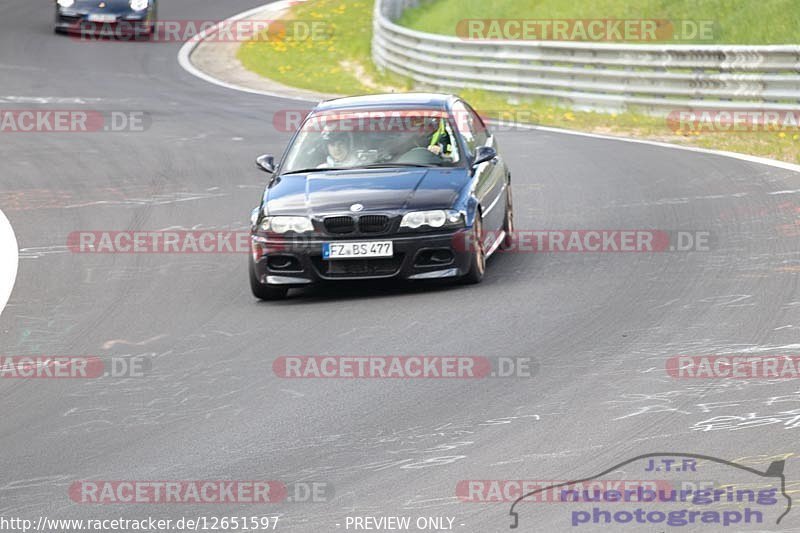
[283,110,461,174]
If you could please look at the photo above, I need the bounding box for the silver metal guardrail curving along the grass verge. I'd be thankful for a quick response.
[372,0,800,113]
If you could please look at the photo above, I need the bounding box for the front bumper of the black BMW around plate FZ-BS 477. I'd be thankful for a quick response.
[251,229,471,287]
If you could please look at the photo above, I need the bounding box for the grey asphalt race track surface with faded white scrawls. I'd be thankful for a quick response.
[0,0,800,532]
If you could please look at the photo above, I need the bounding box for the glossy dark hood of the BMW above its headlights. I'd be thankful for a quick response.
[266,168,469,216]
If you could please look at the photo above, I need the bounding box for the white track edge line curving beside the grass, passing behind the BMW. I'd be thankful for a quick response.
[178,0,800,173]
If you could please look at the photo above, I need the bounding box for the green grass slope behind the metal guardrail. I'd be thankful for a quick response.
[399,0,800,44]
